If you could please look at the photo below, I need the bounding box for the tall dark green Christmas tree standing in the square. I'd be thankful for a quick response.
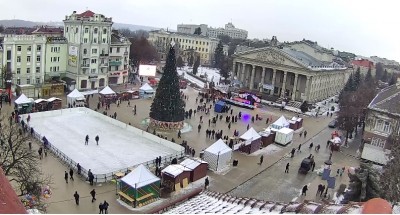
[150,45,185,129]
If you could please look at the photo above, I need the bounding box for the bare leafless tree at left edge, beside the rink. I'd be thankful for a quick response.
[0,117,51,210]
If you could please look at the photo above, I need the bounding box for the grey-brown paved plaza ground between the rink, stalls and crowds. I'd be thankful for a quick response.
[2,82,357,213]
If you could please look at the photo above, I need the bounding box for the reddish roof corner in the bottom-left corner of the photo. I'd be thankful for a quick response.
[0,167,27,214]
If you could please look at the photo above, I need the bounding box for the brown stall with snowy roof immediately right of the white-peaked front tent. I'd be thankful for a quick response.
[161,164,190,192]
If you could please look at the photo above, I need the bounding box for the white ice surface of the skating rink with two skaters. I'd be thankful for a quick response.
[27,108,183,174]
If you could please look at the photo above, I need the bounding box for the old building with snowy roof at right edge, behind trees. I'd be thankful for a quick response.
[361,84,400,165]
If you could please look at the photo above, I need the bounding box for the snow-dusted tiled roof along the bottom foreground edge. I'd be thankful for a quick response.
[165,190,376,214]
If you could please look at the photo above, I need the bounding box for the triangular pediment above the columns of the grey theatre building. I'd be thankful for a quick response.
[236,48,305,68]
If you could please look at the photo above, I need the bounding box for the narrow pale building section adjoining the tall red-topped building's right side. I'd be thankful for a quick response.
[107,31,131,85]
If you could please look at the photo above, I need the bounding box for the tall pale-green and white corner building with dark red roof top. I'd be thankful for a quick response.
[64,10,113,90]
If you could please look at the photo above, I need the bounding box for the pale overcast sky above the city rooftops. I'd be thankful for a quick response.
[0,0,400,61]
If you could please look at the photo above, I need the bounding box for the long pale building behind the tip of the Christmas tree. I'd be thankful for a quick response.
[149,30,219,65]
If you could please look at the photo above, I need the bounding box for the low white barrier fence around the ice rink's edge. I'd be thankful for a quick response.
[21,107,185,183]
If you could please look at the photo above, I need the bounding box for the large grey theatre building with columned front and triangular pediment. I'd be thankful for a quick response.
[233,43,352,102]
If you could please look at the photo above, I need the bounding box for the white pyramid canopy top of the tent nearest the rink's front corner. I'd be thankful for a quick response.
[121,164,160,189]
